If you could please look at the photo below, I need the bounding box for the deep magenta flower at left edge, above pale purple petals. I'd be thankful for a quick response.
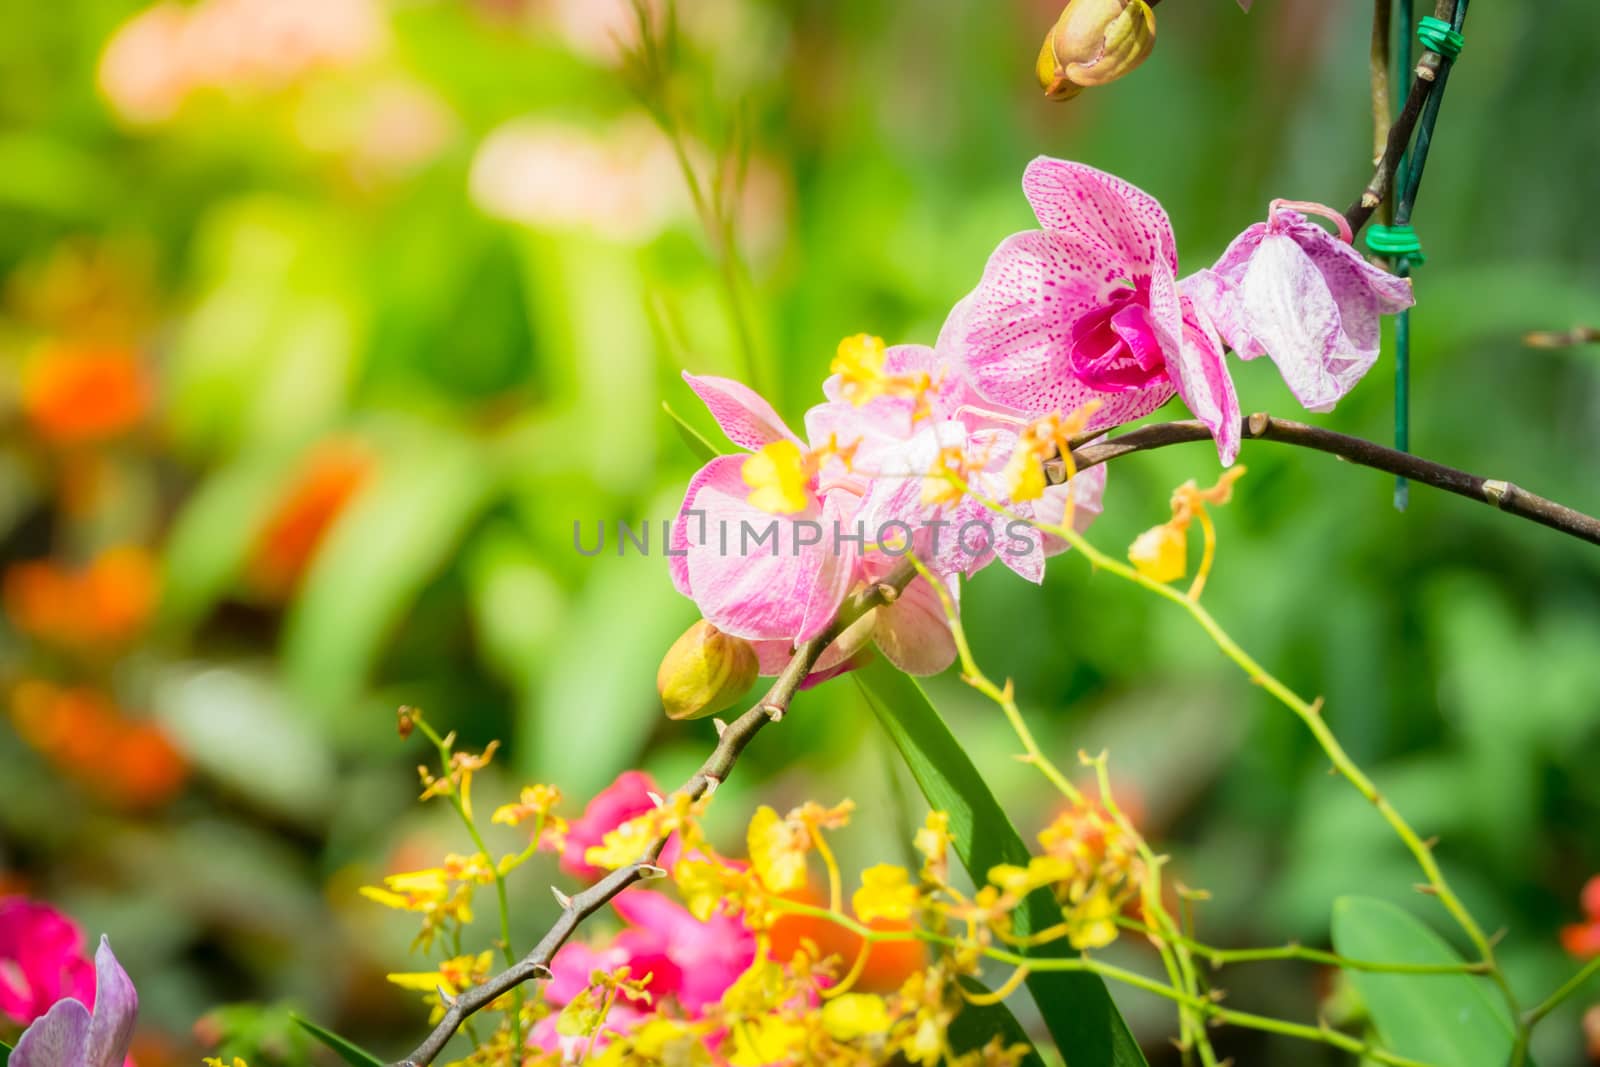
[0,897,94,1025]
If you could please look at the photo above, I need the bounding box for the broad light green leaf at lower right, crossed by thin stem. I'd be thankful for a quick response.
[1333,896,1512,1067]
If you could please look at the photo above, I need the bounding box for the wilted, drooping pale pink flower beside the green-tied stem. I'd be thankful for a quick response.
[1190,200,1414,411]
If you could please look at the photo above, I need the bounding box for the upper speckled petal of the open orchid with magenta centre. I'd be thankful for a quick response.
[1022,155,1178,277]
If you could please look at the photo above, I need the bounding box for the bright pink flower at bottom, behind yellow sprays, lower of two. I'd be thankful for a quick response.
[530,889,755,1057]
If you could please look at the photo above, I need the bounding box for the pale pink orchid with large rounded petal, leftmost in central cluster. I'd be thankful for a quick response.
[670,371,955,685]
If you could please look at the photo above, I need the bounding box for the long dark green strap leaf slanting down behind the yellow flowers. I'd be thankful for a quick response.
[851,659,1146,1067]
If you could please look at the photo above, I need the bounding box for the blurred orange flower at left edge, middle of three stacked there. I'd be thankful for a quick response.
[3,545,160,649]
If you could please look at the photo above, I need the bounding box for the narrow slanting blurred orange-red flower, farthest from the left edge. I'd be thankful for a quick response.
[245,438,374,600]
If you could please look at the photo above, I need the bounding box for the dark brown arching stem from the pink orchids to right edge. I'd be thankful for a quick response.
[1045,411,1600,544]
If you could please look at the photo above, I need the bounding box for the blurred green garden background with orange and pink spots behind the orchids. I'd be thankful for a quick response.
[0,0,1600,1067]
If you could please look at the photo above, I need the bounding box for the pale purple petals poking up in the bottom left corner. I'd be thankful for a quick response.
[11,937,139,1067]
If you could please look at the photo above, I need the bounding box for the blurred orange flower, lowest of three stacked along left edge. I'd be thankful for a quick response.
[11,680,189,809]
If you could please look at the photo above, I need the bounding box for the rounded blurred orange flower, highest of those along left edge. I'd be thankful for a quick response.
[22,344,154,445]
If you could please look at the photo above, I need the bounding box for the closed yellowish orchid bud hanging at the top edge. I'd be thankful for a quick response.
[1037,0,1155,101]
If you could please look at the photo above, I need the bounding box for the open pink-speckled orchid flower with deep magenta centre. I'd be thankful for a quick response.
[954,157,1240,464]
